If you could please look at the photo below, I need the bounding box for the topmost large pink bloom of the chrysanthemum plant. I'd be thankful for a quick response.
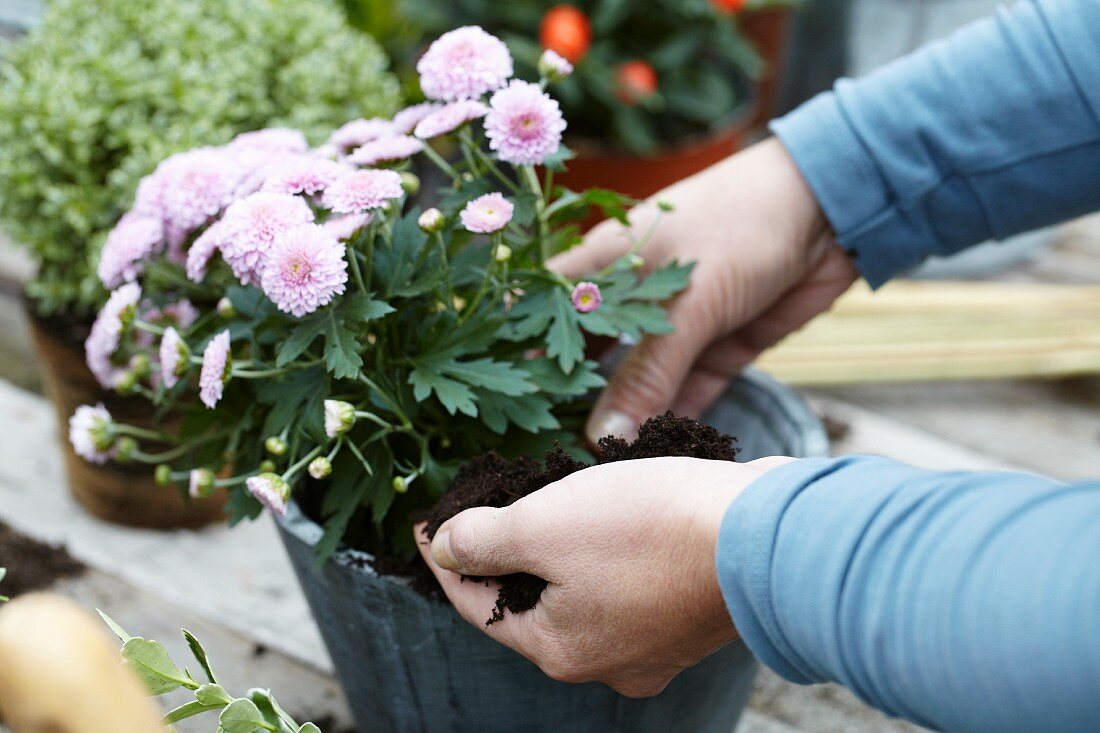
[416,25,513,101]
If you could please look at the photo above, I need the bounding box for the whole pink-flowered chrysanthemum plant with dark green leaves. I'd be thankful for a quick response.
[70,28,691,556]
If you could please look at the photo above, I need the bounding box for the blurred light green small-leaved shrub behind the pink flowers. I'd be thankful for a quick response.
[0,0,399,314]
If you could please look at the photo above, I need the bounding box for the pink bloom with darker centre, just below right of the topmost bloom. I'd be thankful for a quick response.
[485,79,565,165]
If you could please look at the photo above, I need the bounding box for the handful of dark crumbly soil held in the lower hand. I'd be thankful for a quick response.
[413,413,737,625]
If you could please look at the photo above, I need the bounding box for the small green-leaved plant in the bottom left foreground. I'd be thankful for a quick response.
[99,611,321,733]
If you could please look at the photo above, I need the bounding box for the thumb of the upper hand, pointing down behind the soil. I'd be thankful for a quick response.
[585,306,710,445]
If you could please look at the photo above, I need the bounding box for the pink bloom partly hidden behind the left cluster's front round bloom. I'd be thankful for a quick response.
[220,189,314,285]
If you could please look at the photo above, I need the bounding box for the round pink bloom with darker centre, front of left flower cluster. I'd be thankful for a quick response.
[261,225,348,318]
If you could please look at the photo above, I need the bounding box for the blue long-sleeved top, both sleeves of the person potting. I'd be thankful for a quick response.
[717,0,1100,733]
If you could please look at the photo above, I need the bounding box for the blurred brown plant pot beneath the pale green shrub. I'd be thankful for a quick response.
[28,307,226,529]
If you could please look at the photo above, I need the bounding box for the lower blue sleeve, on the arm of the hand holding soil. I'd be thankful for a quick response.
[717,457,1100,733]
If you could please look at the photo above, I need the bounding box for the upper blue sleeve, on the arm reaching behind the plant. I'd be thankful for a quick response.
[772,0,1100,287]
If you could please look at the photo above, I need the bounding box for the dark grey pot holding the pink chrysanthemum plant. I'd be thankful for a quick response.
[281,372,828,733]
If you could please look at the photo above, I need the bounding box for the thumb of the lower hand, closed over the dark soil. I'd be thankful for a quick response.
[431,506,535,577]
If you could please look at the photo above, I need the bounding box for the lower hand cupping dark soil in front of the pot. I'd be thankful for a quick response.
[416,458,794,697]
